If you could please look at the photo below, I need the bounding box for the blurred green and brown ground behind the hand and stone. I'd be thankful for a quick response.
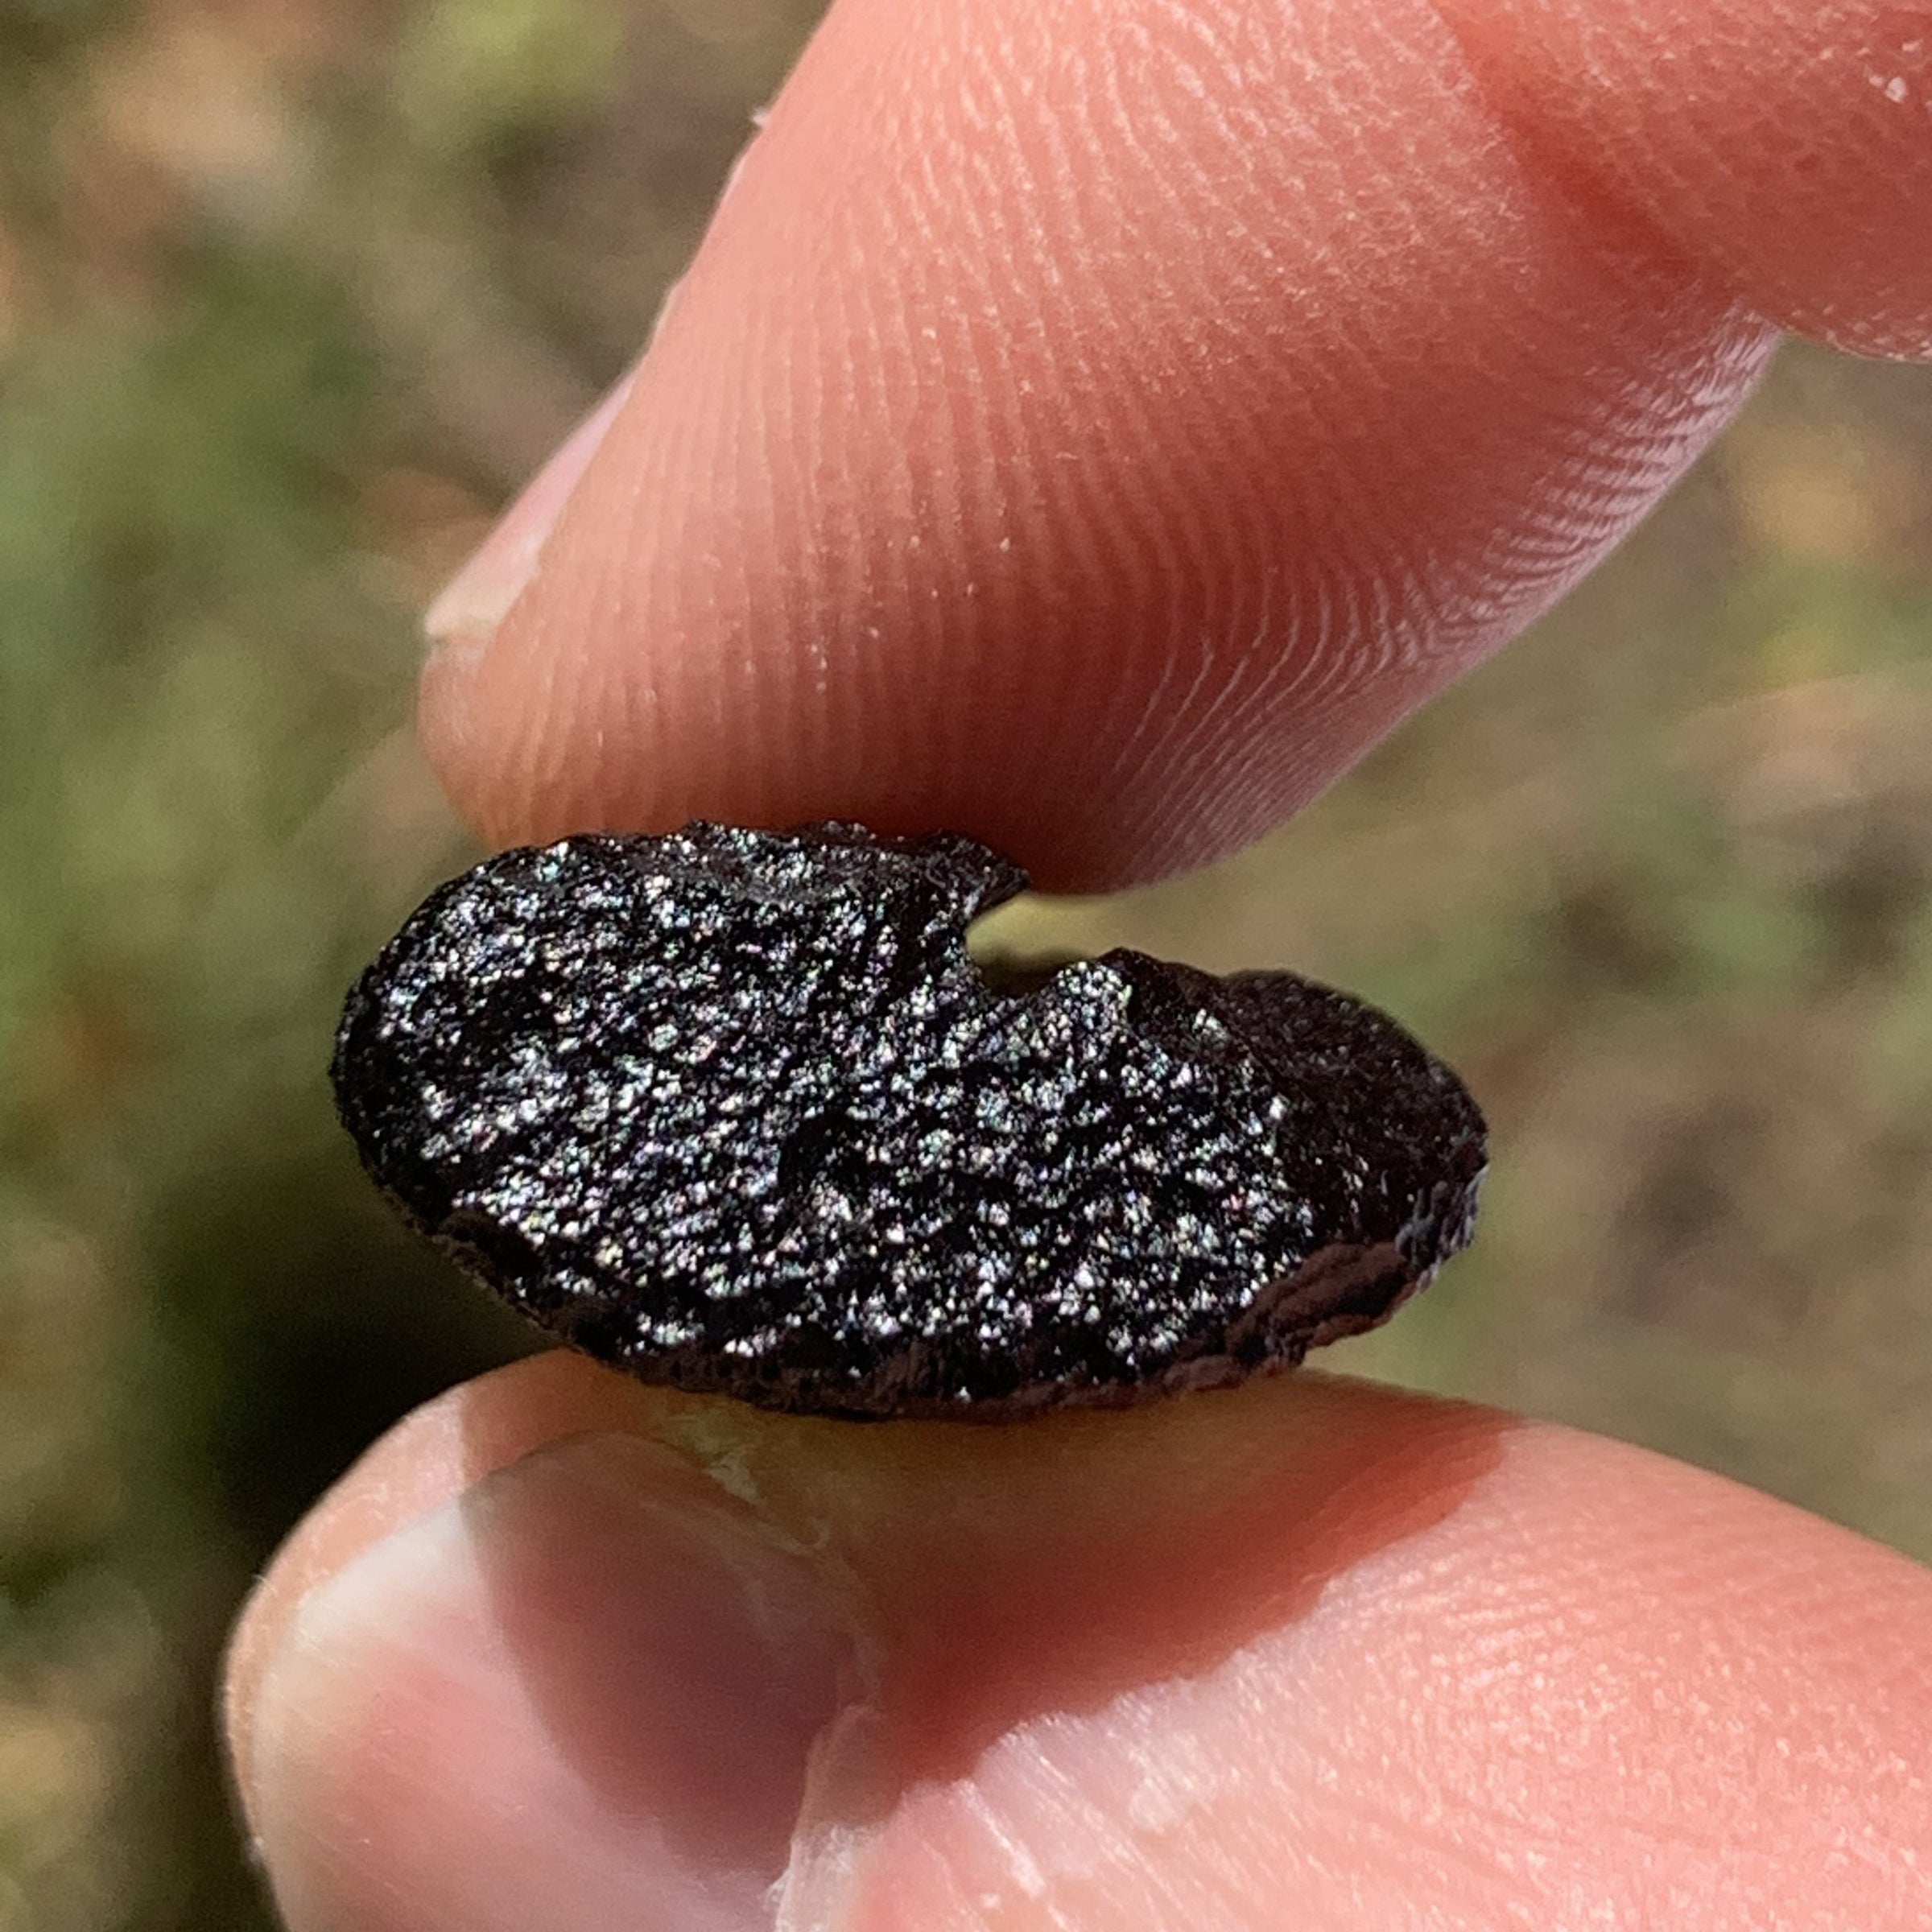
[0,0,1932,1932]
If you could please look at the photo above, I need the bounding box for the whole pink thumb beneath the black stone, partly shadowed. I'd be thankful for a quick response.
[230,1356,1932,1932]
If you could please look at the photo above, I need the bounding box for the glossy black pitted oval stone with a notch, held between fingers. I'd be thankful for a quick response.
[334,825,1484,1418]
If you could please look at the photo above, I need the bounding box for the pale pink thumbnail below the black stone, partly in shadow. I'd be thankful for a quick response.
[250,1431,856,1932]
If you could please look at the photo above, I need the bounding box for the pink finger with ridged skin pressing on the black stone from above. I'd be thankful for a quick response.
[423,0,1932,889]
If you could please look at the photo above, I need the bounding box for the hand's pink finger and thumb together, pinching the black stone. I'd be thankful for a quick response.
[228,0,1932,1932]
